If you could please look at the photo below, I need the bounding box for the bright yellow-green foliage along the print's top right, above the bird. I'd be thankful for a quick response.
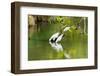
[48,16,87,34]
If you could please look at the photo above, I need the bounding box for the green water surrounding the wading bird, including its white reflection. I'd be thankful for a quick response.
[28,23,88,60]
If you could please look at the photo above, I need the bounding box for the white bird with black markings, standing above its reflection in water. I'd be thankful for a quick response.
[49,27,70,42]
